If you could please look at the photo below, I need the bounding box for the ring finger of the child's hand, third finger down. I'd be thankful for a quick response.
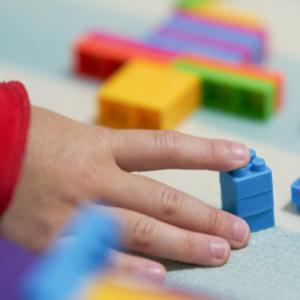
[112,208,230,266]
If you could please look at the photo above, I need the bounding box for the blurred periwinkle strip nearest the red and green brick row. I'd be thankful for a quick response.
[144,32,244,63]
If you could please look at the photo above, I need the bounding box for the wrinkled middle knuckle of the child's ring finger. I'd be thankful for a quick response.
[132,217,156,247]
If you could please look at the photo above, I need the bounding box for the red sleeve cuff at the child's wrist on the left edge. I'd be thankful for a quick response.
[0,82,30,216]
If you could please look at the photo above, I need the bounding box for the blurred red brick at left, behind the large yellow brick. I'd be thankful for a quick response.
[74,32,175,79]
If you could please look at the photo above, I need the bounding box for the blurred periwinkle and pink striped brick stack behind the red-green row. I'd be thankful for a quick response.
[145,12,266,63]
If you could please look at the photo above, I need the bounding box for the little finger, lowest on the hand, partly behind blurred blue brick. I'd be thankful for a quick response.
[110,251,166,285]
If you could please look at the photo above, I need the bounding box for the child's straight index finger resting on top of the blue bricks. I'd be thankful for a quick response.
[111,130,249,171]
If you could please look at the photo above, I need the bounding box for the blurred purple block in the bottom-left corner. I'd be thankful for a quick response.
[0,238,36,300]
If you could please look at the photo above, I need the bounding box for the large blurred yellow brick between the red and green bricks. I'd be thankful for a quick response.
[98,59,200,129]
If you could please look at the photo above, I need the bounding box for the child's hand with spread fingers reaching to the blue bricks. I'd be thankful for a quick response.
[0,108,250,279]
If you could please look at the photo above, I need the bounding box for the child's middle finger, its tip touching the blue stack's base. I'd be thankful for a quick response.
[104,171,250,248]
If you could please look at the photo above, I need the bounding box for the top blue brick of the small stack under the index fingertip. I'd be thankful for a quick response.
[220,152,273,202]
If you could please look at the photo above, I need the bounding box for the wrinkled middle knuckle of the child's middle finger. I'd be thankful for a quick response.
[160,188,186,216]
